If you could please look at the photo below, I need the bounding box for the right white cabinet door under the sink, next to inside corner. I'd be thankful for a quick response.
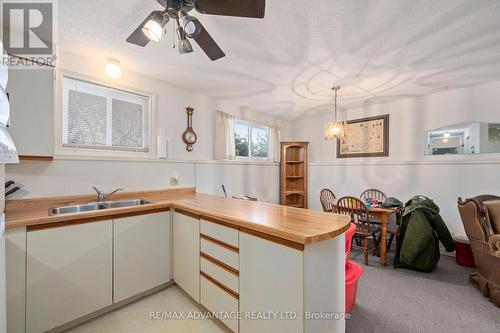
[113,212,171,303]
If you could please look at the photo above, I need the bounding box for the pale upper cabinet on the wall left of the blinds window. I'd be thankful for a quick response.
[6,67,55,157]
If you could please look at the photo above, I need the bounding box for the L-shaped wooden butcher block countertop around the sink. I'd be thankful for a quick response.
[5,188,350,245]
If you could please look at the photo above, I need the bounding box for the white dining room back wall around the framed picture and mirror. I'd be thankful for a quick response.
[293,82,500,234]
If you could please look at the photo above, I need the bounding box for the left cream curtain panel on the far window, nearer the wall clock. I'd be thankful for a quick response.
[214,111,236,160]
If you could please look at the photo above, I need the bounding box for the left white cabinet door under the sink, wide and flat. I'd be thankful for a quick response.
[26,221,113,333]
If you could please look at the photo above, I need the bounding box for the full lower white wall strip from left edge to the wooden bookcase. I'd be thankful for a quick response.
[6,160,279,203]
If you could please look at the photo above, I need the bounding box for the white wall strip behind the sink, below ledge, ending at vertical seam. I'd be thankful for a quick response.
[6,160,195,199]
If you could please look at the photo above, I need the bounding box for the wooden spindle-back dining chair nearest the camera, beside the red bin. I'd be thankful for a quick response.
[334,197,380,265]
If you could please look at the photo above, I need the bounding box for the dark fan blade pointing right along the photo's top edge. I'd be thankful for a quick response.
[194,0,266,18]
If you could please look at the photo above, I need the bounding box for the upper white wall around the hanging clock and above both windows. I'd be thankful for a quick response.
[56,53,291,160]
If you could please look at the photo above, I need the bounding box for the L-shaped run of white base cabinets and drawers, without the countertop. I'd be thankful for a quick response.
[6,211,345,333]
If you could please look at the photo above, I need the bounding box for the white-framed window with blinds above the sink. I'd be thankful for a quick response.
[62,77,151,153]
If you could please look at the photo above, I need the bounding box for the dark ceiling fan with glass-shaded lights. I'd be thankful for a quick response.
[127,0,266,61]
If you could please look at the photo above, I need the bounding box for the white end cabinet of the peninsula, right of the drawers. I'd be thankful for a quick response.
[240,232,345,333]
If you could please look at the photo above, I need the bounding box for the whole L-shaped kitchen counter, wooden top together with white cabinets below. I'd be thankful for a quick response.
[6,188,350,333]
